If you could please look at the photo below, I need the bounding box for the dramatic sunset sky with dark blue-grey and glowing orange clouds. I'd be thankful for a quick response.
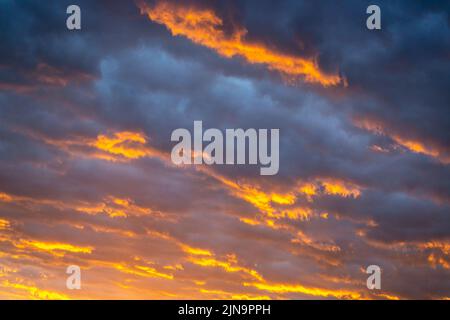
[0,0,450,299]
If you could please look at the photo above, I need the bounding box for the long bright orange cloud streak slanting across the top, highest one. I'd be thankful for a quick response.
[139,1,342,87]
